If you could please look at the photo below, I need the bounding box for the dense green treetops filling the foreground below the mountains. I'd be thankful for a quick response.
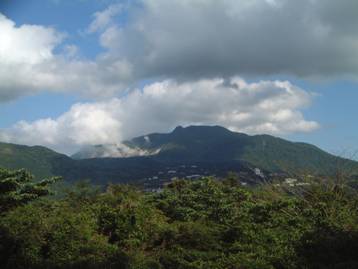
[0,169,358,269]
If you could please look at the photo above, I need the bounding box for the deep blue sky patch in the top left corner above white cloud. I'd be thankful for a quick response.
[1,0,108,57]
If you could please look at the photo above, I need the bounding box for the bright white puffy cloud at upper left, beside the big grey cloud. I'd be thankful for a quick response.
[0,13,132,102]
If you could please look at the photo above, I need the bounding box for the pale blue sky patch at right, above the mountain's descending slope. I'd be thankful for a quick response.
[287,80,358,157]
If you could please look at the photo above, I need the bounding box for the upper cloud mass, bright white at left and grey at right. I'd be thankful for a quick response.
[0,0,358,102]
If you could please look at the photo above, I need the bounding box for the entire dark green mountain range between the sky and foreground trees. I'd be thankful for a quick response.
[0,126,358,185]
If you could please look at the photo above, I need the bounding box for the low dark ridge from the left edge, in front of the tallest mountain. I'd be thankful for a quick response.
[0,140,261,184]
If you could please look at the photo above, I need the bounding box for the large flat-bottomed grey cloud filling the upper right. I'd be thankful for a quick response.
[97,0,358,79]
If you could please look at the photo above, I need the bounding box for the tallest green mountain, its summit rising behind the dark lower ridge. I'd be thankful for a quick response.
[72,126,358,175]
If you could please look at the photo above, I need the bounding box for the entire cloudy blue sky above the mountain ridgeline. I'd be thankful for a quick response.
[0,0,358,157]
